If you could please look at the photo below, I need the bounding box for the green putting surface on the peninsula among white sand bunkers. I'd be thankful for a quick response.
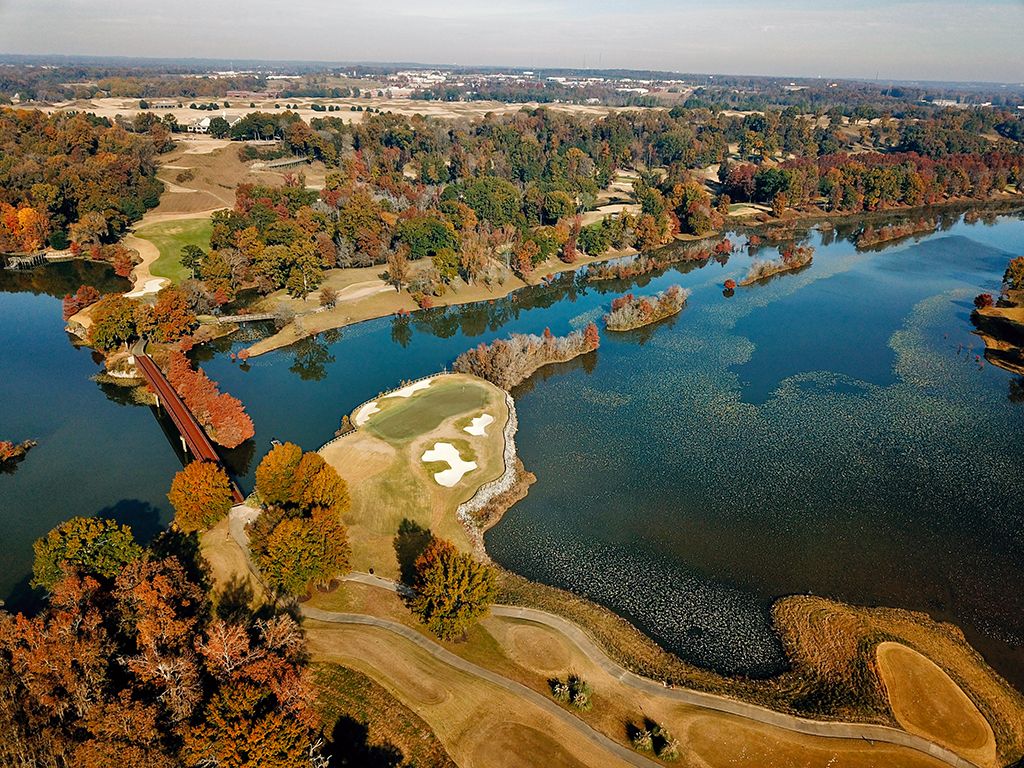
[364,380,489,443]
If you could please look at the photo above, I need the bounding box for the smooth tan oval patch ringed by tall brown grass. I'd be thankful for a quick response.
[877,642,995,765]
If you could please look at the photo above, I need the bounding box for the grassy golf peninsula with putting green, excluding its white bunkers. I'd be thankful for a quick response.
[321,375,508,578]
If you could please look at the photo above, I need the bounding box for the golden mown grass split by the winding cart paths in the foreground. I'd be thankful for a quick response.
[306,584,954,768]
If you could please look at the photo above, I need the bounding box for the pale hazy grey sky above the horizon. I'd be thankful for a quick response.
[0,0,1024,83]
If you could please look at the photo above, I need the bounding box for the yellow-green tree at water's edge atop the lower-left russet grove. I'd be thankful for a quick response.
[32,517,142,590]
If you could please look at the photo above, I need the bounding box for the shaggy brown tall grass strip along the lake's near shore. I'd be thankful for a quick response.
[499,571,1024,764]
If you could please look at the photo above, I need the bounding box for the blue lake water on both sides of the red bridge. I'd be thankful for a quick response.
[0,213,1024,687]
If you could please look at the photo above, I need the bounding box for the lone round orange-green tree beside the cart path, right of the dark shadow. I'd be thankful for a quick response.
[409,537,498,640]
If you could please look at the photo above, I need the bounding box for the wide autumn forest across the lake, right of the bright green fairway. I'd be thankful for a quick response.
[163,108,1024,311]
